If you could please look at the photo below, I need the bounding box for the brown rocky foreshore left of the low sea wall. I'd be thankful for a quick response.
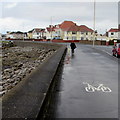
[0,46,56,96]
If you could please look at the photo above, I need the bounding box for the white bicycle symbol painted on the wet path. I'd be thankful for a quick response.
[83,82,112,93]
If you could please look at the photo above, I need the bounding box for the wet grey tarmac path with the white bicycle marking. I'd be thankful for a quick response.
[46,44,118,118]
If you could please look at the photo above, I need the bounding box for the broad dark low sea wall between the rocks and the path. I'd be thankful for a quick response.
[2,42,66,120]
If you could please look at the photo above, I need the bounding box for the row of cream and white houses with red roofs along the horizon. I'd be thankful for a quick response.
[6,21,120,41]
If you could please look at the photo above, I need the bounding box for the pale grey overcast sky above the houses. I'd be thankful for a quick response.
[0,0,118,33]
